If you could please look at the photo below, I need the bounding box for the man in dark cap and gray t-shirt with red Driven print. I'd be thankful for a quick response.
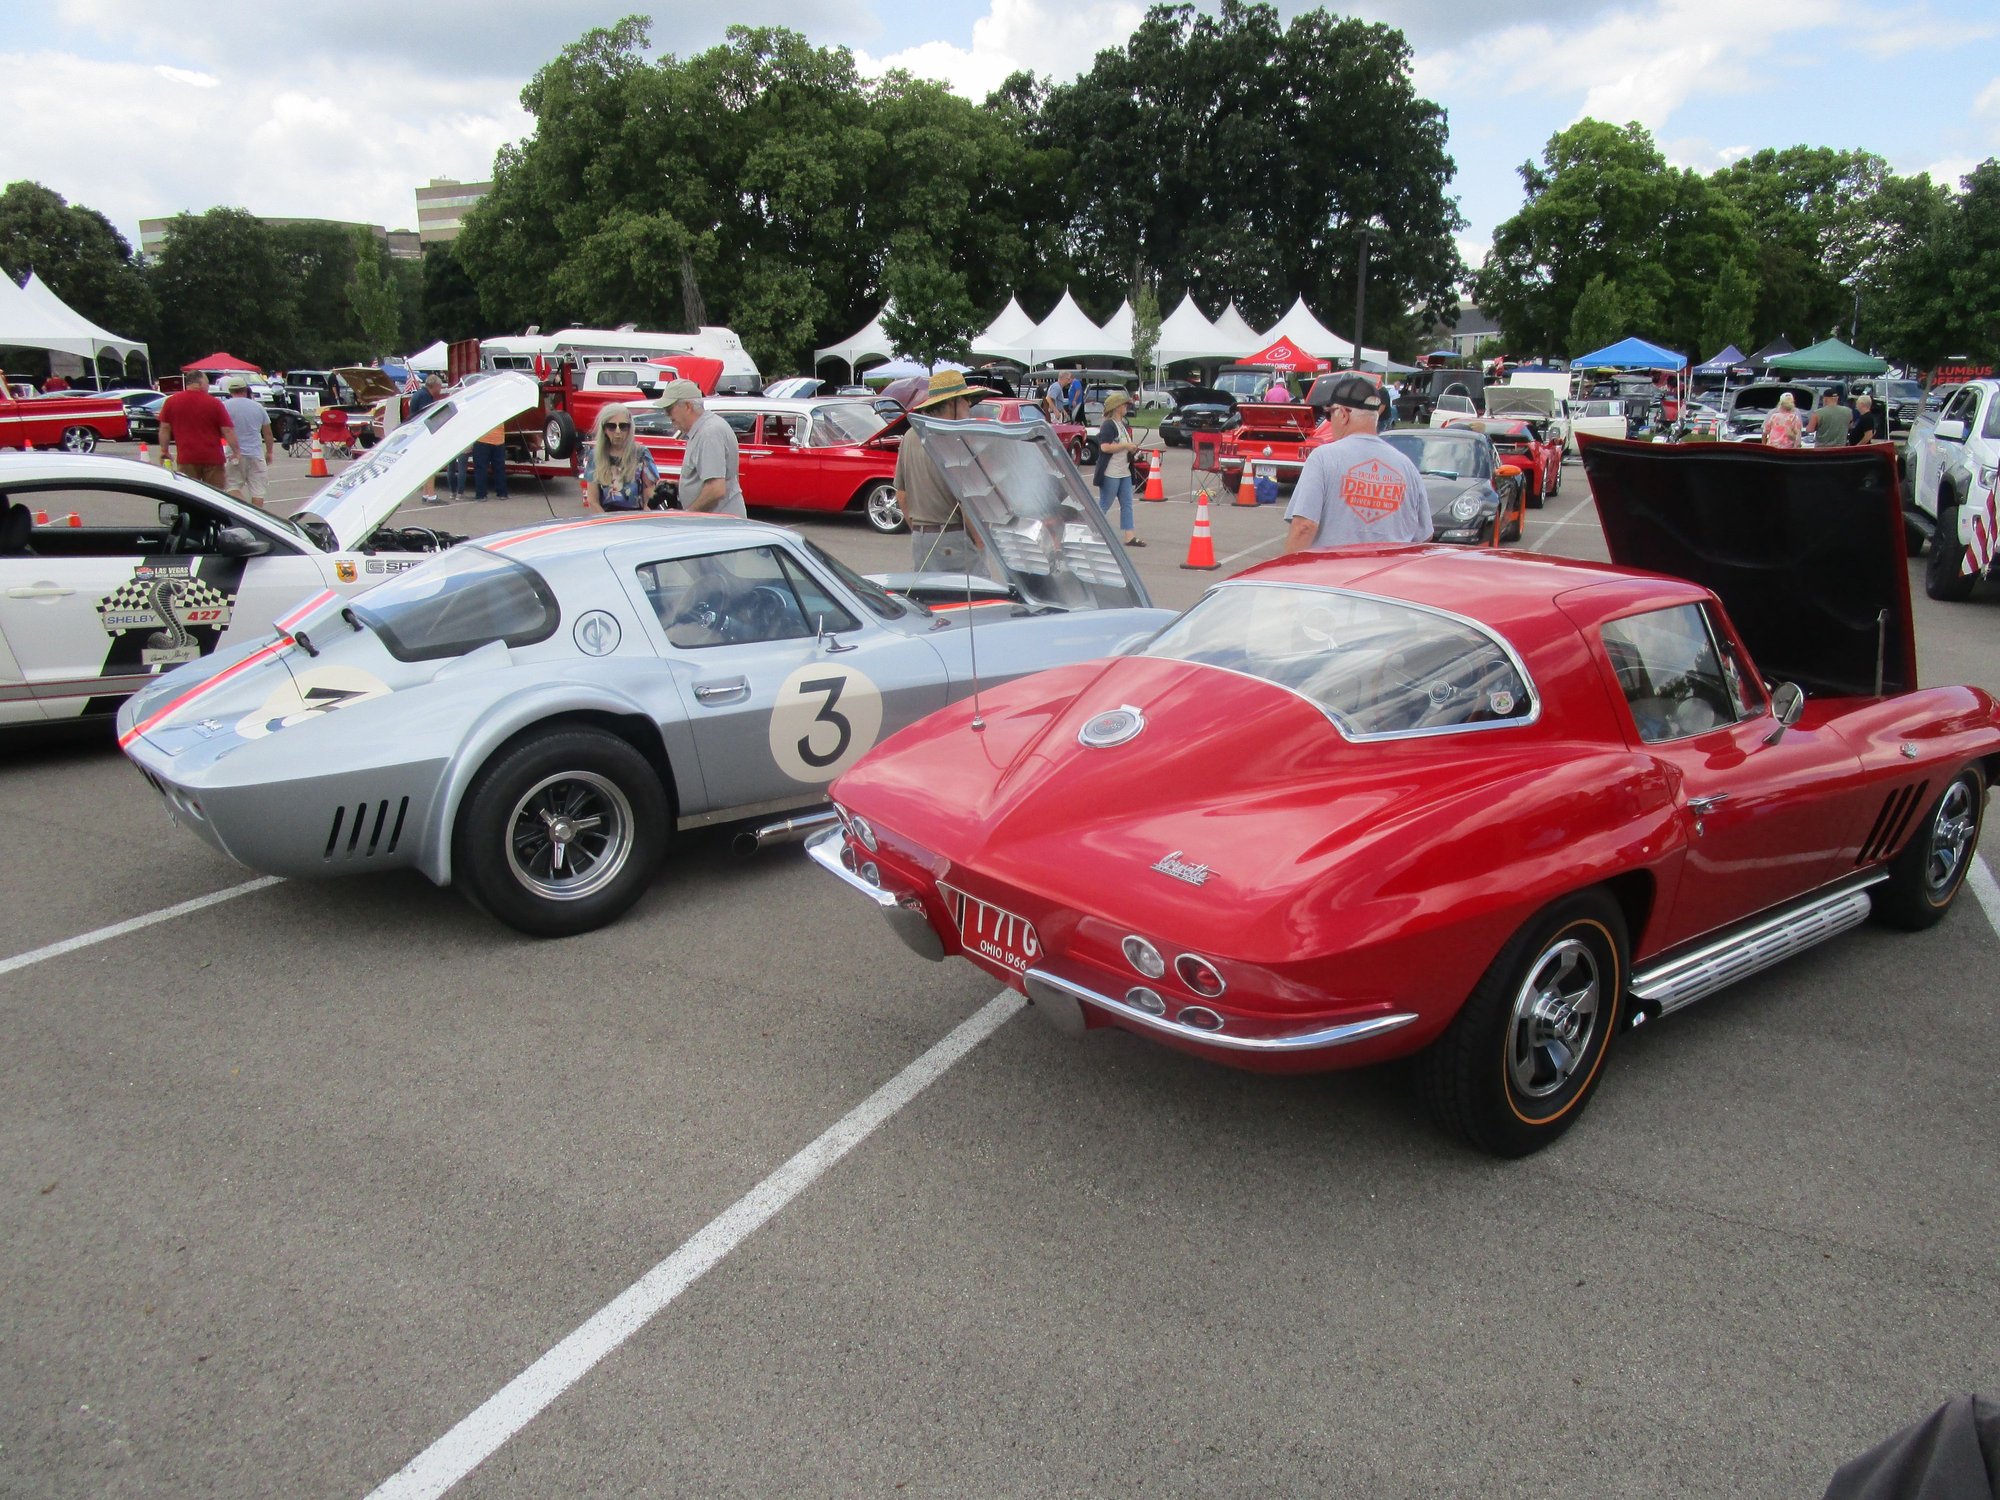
[1284,374,1432,552]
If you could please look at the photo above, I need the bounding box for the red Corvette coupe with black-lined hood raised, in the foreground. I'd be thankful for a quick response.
[810,440,2000,1156]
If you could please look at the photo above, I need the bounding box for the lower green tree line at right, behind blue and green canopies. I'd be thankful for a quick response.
[1472,120,2000,368]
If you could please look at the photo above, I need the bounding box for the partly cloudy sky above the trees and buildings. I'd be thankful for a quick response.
[0,0,2000,276]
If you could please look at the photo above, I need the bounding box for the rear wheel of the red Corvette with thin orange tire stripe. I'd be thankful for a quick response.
[1420,890,1626,1156]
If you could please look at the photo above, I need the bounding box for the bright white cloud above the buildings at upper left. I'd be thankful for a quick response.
[0,52,530,248]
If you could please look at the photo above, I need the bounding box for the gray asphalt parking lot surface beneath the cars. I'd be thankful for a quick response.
[0,440,2000,1496]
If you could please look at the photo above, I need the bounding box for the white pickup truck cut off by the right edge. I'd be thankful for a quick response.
[1902,380,2000,600]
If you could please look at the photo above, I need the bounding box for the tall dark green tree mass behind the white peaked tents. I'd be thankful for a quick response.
[1040,0,1464,332]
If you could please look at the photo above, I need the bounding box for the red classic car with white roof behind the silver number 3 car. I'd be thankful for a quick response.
[636,396,904,532]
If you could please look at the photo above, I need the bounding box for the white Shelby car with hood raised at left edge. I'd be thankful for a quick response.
[0,374,536,730]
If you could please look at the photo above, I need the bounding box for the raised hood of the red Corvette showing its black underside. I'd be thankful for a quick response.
[1578,436,1916,696]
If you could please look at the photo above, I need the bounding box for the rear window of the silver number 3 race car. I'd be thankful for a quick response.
[352,544,562,662]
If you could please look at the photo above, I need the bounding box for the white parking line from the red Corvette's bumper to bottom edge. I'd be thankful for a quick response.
[368,990,1026,1500]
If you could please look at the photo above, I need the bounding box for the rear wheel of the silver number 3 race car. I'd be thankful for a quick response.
[452,728,672,938]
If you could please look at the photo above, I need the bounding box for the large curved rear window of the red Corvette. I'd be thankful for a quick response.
[1142,584,1534,740]
